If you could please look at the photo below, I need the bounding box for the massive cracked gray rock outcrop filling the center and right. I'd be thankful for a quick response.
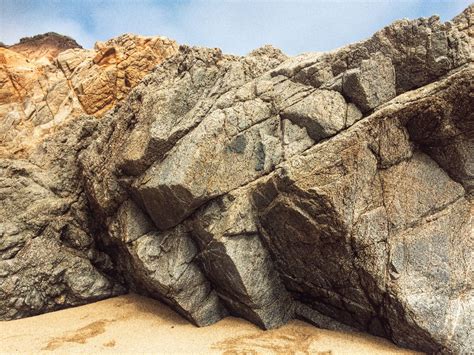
[80,11,473,352]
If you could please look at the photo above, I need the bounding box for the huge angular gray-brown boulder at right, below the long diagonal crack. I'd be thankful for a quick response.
[254,66,474,353]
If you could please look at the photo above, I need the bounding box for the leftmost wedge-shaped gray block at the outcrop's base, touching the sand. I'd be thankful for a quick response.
[104,201,227,326]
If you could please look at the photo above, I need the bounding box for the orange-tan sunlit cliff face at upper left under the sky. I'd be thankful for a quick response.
[0,34,178,157]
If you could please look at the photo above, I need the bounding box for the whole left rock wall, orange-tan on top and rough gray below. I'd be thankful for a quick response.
[0,33,176,319]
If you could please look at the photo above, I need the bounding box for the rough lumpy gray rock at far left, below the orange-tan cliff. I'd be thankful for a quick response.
[0,119,125,319]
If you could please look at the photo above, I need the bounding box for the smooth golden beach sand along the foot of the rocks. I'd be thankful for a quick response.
[0,294,422,355]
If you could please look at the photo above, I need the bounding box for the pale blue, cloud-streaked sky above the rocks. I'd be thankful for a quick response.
[0,0,471,55]
